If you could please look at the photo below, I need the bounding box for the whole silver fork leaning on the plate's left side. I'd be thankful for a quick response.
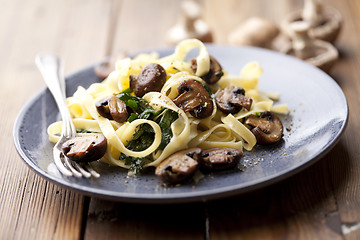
[35,54,100,178]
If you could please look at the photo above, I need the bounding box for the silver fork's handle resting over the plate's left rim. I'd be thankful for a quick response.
[35,54,72,135]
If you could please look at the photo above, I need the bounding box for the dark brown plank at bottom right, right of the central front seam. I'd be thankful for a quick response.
[208,159,342,239]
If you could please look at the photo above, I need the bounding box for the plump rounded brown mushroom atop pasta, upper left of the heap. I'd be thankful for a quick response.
[130,63,166,97]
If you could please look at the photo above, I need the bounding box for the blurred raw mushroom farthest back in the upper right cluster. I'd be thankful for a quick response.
[282,0,342,43]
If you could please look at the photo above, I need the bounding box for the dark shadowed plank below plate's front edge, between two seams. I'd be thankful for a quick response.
[85,198,205,240]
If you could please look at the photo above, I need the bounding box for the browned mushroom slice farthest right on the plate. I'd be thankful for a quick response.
[245,111,283,145]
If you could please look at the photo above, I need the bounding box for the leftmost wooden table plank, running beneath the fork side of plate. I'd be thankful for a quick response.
[0,0,110,239]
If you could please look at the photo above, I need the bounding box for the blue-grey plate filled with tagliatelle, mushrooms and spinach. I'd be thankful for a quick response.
[14,39,348,203]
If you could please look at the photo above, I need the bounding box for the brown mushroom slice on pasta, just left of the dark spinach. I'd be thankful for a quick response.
[95,96,129,123]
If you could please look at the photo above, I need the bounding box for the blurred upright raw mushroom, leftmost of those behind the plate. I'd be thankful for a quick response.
[166,0,213,45]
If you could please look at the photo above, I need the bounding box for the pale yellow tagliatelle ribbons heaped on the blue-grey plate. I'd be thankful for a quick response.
[48,39,289,175]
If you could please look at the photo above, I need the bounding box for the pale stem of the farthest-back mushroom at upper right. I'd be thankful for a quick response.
[302,0,324,27]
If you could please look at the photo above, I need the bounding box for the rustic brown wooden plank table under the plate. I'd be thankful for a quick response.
[0,0,360,240]
